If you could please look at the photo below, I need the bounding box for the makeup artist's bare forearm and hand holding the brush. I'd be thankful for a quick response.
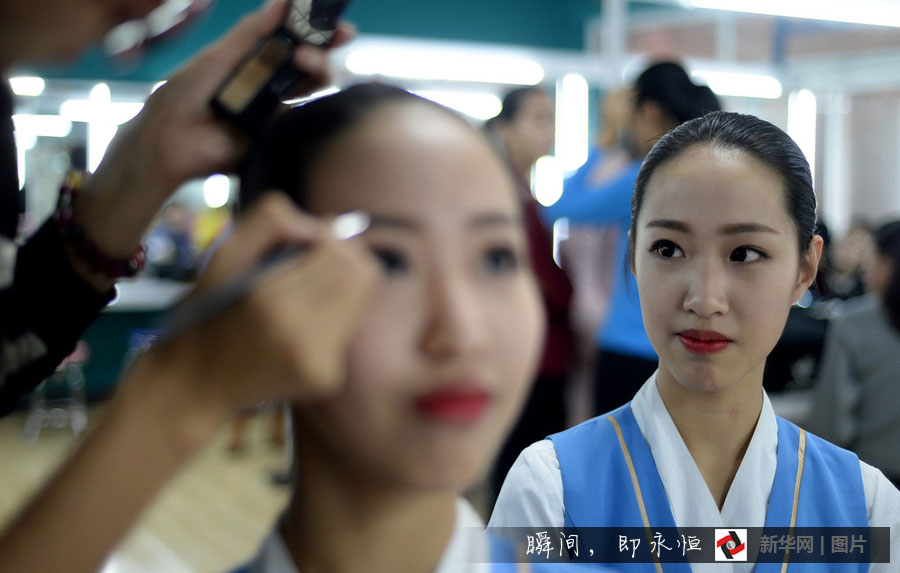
[0,194,378,573]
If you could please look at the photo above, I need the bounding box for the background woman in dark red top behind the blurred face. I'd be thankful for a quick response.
[485,87,574,504]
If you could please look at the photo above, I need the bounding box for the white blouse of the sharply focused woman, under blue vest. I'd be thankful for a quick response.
[488,374,900,573]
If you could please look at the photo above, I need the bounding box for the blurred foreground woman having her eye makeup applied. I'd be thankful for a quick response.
[232,84,596,573]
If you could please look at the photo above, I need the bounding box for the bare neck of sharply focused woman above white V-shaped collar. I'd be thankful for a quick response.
[656,364,764,509]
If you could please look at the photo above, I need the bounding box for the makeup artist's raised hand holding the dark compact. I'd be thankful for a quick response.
[68,0,354,290]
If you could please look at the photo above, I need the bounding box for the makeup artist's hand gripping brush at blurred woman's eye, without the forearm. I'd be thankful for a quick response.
[128,193,379,442]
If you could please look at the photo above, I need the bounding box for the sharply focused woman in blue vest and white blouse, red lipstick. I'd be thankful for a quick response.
[490,112,900,572]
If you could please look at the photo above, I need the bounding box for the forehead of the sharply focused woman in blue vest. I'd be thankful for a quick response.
[638,145,793,237]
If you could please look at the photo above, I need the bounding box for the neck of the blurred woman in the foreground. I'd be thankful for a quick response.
[281,440,456,573]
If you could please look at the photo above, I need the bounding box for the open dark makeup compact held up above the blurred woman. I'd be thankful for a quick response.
[210,0,349,133]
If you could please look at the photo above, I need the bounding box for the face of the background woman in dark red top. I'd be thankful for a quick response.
[501,92,556,165]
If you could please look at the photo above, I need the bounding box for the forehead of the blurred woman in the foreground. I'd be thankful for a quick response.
[309,103,517,218]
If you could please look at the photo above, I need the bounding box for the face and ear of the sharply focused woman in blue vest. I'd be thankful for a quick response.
[634,145,821,392]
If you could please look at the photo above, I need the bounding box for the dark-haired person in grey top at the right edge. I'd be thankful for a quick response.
[807,221,900,485]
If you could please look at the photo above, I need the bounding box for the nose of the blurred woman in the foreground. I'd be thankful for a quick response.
[422,272,489,359]
